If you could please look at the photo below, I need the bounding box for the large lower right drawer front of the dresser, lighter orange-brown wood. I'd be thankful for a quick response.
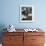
[24,34,44,46]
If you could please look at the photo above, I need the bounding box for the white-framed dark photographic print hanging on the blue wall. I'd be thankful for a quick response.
[20,5,34,22]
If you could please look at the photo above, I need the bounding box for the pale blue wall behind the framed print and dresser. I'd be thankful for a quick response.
[0,0,46,28]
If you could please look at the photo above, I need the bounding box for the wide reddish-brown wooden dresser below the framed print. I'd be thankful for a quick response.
[2,29,45,46]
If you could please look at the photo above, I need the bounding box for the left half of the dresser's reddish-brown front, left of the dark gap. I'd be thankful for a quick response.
[2,32,23,46]
